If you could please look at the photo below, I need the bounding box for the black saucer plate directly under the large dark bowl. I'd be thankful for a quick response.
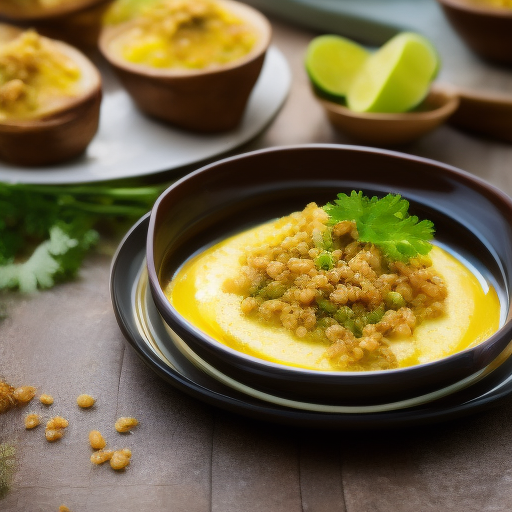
[110,214,512,429]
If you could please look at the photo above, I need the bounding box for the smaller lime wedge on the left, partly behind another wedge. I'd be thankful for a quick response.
[306,35,370,99]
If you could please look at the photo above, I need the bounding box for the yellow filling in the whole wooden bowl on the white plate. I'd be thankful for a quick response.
[112,0,257,69]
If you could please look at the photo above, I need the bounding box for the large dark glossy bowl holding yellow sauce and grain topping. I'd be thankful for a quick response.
[147,145,512,404]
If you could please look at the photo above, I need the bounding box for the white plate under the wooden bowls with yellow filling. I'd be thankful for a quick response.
[0,47,291,184]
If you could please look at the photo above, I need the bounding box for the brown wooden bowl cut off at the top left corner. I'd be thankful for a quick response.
[0,0,112,48]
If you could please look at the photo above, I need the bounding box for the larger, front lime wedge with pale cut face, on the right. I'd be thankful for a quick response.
[347,32,440,113]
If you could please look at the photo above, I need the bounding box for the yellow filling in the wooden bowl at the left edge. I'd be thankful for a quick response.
[0,30,81,120]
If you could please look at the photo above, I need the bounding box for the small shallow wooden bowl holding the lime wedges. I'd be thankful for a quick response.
[316,89,459,146]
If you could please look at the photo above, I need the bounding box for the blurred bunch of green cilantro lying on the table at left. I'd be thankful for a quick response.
[0,182,165,292]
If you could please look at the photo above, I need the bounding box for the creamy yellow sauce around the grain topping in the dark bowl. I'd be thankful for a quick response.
[164,221,500,371]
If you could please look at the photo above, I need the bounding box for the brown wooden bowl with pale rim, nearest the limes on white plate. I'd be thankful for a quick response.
[99,0,271,133]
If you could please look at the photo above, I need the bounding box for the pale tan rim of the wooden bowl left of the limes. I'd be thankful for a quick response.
[98,0,272,80]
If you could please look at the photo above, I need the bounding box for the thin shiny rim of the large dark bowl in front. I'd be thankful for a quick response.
[146,143,512,380]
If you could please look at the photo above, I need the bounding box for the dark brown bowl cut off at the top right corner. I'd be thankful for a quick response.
[438,0,512,64]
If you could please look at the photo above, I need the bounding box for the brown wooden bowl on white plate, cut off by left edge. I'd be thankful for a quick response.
[0,24,101,166]
